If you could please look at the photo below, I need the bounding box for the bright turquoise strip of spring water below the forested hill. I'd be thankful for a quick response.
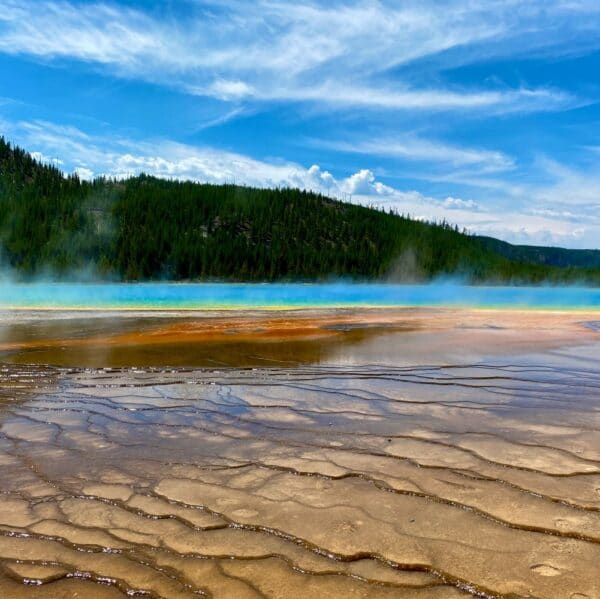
[0,283,600,310]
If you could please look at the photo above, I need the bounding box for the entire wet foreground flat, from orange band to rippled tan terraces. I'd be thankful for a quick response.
[0,310,600,599]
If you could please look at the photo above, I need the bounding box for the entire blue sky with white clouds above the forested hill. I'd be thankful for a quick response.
[0,0,600,248]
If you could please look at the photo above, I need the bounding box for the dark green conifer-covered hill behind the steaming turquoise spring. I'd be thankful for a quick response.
[0,138,600,284]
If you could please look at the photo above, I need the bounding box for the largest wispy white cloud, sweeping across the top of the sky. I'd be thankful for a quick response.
[0,0,600,111]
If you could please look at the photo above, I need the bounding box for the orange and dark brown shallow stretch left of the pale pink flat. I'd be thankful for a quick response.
[0,313,420,367]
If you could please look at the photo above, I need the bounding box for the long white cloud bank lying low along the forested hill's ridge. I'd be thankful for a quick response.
[0,121,600,247]
